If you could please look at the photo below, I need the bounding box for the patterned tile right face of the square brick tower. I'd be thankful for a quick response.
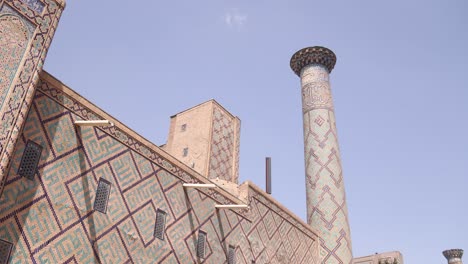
[208,104,239,183]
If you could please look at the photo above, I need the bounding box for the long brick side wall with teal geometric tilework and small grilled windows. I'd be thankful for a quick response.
[0,73,319,264]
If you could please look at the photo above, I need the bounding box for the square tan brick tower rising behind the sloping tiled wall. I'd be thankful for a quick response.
[164,100,240,187]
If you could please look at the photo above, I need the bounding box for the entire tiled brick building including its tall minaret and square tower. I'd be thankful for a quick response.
[0,0,434,264]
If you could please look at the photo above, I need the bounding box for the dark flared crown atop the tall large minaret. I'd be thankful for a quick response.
[290,46,336,76]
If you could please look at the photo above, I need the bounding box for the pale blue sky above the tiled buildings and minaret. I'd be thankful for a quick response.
[45,0,468,264]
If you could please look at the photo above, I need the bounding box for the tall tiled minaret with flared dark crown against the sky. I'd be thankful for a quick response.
[290,47,353,264]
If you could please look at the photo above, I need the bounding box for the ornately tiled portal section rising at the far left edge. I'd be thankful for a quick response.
[0,0,63,198]
